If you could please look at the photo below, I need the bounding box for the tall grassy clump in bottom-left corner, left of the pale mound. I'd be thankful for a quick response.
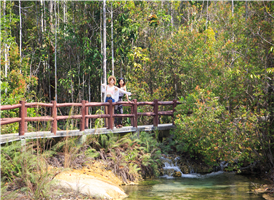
[0,142,53,199]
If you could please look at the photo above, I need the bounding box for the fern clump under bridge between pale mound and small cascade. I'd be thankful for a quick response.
[88,132,161,183]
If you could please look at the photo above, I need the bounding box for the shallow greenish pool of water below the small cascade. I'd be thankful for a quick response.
[123,172,264,200]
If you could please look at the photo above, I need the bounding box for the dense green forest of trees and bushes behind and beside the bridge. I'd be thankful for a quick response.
[0,0,274,170]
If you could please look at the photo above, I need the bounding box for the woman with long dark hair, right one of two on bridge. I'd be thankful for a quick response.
[114,78,129,128]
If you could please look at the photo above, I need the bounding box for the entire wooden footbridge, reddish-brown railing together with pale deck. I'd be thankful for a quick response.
[0,99,179,144]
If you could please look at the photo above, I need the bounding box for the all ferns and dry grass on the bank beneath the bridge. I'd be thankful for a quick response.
[0,132,162,199]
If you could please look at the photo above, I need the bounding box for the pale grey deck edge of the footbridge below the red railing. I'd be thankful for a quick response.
[0,123,175,144]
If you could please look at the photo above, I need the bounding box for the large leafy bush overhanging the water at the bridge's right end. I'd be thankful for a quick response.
[174,89,265,167]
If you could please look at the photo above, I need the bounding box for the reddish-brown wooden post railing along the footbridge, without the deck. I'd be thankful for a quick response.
[0,99,179,135]
